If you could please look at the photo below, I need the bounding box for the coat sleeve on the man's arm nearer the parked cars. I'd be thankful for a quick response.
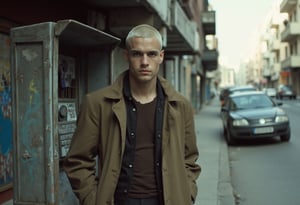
[184,103,201,202]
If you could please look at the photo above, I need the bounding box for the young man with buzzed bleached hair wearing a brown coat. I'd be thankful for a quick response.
[64,24,201,205]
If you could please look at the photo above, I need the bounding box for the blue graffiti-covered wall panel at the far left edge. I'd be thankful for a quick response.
[0,33,13,192]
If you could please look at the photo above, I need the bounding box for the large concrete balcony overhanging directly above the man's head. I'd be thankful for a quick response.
[82,0,200,54]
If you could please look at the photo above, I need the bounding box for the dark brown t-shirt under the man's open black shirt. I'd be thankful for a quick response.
[129,98,157,198]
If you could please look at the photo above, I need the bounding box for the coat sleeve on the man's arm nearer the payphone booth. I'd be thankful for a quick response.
[63,95,99,205]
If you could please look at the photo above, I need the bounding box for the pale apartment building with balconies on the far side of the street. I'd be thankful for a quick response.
[245,0,300,96]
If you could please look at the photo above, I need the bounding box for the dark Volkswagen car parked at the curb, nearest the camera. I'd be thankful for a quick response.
[221,91,291,145]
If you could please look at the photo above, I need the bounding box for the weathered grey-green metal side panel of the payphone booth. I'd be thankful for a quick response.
[11,23,58,204]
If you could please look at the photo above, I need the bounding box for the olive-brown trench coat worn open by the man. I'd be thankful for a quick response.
[64,71,201,205]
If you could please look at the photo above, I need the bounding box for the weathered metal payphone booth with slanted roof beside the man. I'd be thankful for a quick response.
[11,20,120,205]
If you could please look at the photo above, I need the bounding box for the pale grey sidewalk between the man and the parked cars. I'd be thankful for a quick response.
[195,98,235,205]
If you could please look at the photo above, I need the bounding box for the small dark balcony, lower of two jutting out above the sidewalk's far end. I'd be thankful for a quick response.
[201,49,219,71]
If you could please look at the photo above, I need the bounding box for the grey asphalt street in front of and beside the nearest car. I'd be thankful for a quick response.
[228,99,300,205]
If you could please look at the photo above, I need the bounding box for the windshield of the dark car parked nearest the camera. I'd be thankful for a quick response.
[231,95,275,110]
